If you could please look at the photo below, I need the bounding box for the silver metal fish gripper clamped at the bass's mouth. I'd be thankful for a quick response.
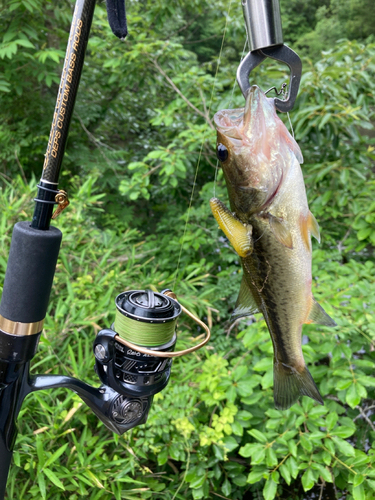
[237,0,302,113]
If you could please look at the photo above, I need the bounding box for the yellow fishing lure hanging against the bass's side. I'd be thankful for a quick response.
[210,198,253,258]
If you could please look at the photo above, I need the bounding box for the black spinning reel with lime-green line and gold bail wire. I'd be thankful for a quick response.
[93,290,211,428]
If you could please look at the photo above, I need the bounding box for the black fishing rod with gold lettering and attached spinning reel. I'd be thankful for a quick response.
[0,0,210,500]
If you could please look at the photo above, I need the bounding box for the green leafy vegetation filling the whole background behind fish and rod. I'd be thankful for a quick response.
[0,0,375,500]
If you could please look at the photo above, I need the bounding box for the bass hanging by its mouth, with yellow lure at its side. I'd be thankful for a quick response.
[210,85,337,410]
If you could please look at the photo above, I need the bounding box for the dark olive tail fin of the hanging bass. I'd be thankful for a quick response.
[273,359,324,410]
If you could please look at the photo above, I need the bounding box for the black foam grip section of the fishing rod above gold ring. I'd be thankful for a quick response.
[0,222,62,323]
